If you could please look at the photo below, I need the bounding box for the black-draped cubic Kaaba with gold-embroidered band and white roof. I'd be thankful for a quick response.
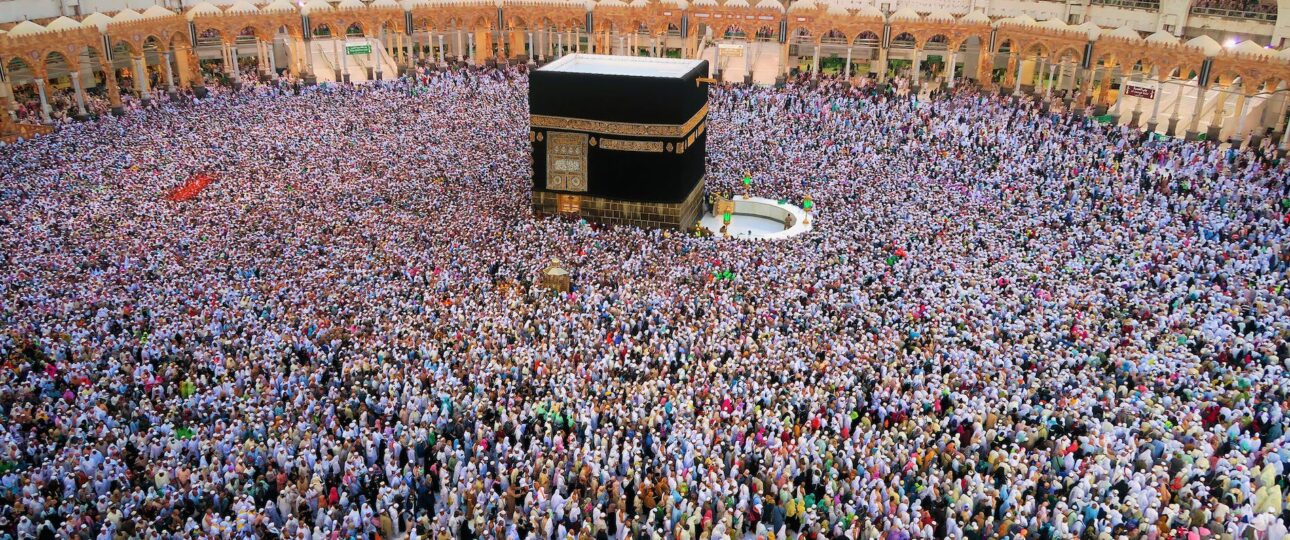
[529,54,708,229]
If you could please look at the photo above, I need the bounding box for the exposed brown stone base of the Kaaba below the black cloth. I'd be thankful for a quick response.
[533,179,703,231]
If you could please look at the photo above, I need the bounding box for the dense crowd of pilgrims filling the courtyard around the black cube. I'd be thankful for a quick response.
[0,67,1290,540]
